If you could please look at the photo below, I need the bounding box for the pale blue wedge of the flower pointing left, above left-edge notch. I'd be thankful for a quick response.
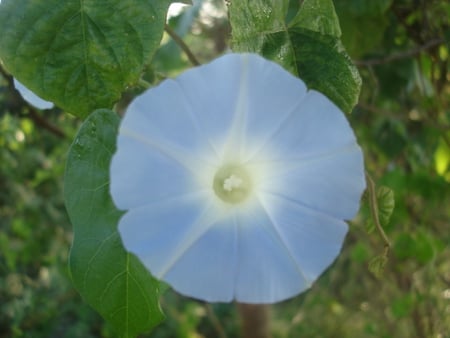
[110,133,206,209]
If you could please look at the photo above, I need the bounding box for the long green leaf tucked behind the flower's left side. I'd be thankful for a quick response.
[64,109,163,337]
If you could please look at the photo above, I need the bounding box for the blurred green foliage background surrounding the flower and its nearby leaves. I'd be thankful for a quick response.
[0,0,450,338]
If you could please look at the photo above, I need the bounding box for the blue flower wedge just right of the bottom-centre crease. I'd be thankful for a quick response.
[235,201,311,303]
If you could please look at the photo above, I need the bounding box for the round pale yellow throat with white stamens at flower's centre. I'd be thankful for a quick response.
[212,163,253,204]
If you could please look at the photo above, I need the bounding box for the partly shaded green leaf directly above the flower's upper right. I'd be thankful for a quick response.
[230,0,361,112]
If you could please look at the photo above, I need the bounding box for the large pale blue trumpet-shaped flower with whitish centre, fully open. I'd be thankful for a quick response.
[110,54,365,303]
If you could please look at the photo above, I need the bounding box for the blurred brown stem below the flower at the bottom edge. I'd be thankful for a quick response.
[237,303,271,338]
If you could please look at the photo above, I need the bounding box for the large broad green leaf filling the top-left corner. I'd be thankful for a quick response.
[0,0,170,117]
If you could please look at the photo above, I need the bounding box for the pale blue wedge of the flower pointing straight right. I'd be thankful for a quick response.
[261,144,365,220]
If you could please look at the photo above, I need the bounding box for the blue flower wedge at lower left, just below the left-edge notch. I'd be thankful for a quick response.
[119,193,219,278]
